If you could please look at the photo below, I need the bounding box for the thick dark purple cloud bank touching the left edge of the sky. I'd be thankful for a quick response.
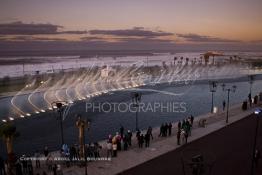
[0,21,87,35]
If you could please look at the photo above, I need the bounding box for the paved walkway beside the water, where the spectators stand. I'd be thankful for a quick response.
[35,102,262,175]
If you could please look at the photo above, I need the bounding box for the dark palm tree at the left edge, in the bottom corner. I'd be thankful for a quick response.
[0,122,19,174]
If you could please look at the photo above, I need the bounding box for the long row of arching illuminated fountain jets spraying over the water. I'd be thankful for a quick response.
[2,56,250,122]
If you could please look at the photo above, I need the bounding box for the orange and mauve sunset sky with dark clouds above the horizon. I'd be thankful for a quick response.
[0,0,262,51]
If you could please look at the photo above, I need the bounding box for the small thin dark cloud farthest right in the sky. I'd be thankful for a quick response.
[176,33,240,43]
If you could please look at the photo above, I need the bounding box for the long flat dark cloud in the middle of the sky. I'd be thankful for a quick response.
[89,27,173,37]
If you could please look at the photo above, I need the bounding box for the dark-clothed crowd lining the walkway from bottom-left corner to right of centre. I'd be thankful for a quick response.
[0,115,194,175]
